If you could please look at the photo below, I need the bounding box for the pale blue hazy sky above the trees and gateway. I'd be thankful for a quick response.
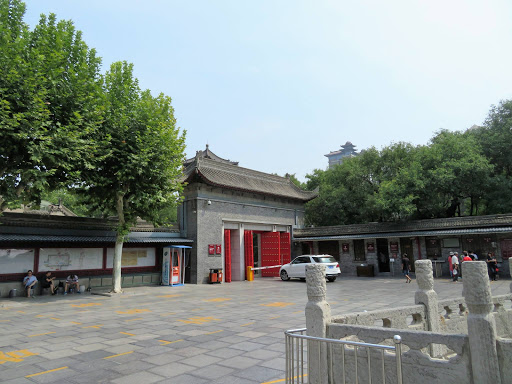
[25,0,512,180]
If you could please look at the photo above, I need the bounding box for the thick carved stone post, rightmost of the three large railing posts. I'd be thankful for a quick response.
[463,261,501,384]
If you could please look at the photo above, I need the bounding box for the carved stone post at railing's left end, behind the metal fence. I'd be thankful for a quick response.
[306,264,331,384]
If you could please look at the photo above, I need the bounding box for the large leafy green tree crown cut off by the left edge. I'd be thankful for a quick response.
[0,0,102,210]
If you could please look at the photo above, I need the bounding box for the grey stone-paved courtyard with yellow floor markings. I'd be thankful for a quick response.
[0,277,510,384]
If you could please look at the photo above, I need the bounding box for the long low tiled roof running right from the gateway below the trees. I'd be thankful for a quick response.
[293,214,512,238]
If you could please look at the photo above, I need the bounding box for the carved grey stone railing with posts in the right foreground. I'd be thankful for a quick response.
[306,260,512,384]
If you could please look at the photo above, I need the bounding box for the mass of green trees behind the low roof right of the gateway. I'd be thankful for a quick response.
[306,131,493,225]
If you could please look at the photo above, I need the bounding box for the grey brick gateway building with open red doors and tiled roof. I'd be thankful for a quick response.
[178,146,317,283]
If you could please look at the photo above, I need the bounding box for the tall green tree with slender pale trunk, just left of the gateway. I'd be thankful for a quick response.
[82,62,185,293]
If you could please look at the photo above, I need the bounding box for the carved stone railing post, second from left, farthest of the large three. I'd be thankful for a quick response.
[414,260,445,357]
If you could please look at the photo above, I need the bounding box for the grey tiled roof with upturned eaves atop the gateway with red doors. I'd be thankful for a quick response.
[182,158,318,202]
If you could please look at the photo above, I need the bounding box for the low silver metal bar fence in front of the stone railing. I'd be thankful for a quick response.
[285,328,402,384]
